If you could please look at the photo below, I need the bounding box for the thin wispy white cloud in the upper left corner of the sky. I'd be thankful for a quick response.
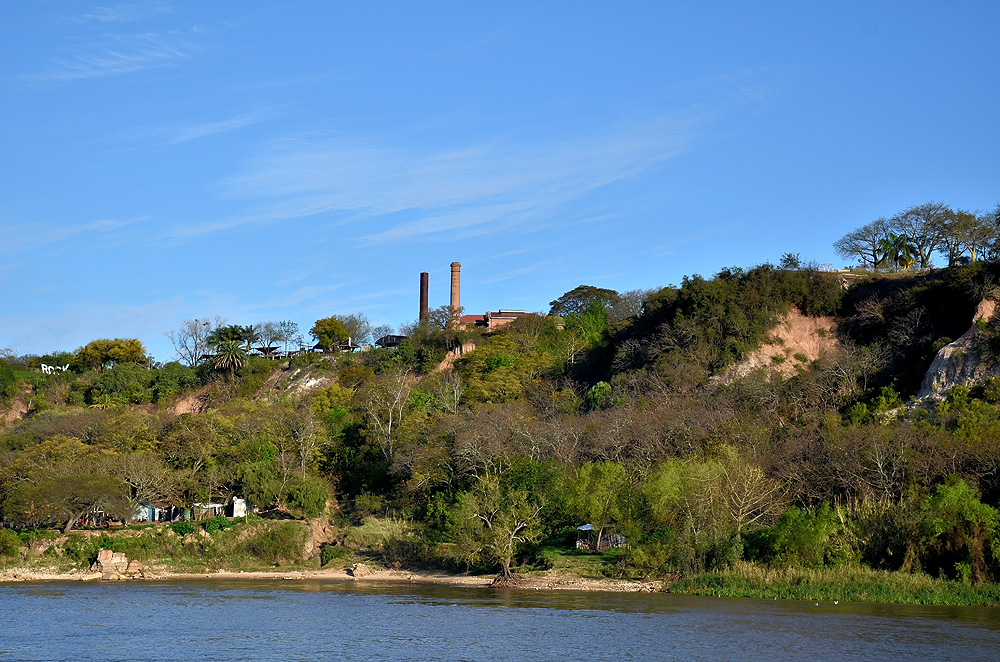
[28,31,200,82]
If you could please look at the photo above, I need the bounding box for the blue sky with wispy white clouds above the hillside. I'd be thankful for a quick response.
[0,0,1000,361]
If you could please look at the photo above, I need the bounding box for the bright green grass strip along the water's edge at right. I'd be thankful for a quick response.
[670,563,1000,606]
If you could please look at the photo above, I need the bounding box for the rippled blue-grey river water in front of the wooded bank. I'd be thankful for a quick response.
[0,580,1000,662]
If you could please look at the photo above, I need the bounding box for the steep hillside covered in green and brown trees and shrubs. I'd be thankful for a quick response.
[0,263,1000,596]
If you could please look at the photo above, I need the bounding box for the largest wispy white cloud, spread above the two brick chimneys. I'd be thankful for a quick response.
[171,116,704,245]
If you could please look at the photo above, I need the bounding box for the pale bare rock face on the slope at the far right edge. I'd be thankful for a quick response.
[917,299,1000,400]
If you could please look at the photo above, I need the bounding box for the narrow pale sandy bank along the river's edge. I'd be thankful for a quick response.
[0,568,663,592]
